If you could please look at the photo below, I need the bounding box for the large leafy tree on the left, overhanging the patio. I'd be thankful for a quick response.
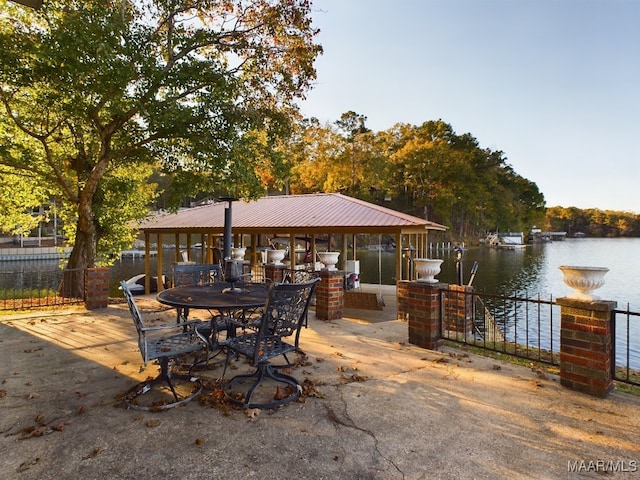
[0,0,321,293]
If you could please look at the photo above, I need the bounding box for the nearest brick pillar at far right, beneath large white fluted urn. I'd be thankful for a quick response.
[556,297,617,397]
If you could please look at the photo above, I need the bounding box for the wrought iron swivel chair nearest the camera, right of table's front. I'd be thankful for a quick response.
[222,278,320,409]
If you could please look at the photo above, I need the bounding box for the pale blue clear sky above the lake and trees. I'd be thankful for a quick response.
[300,0,640,213]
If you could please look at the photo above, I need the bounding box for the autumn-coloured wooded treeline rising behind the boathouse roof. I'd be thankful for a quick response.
[270,112,545,239]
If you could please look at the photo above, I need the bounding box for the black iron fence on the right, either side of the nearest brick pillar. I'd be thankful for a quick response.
[441,290,640,385]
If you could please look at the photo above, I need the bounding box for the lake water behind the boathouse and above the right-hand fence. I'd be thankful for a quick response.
[110,238,640,311]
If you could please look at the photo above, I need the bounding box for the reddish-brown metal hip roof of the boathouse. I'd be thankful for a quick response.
[139,193,446,233]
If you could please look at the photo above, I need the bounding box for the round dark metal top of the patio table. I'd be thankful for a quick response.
[157,282,270,310]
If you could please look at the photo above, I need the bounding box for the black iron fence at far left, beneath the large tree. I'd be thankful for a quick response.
[0,261,84,310]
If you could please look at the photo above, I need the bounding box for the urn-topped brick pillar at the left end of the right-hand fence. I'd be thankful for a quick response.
[397,280,449,350]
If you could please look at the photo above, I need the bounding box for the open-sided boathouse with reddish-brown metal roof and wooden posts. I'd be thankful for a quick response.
[139,193,446,293]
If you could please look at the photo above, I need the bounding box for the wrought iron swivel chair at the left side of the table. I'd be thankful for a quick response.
[120,281,205,411]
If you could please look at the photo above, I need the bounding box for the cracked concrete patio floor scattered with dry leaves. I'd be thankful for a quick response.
[0,297,640,480]
